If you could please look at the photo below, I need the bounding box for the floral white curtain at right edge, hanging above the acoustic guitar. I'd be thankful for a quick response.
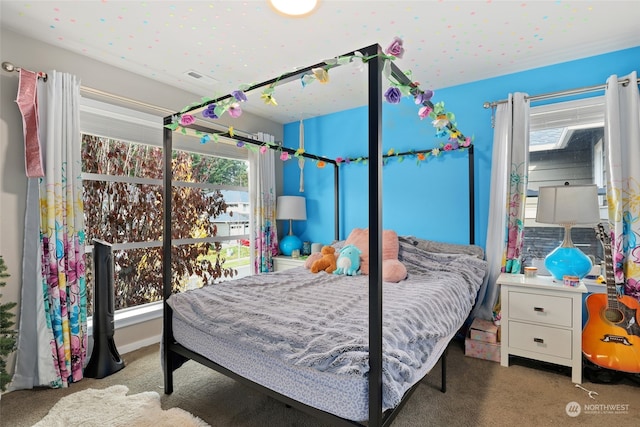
[605,71,640,301]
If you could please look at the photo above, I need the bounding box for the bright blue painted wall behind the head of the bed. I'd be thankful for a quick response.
[283,46,640,246]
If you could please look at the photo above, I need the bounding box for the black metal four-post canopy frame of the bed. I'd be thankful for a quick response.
[162,44,474,427]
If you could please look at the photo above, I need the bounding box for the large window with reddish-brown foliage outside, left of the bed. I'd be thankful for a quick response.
[81,100,250,314]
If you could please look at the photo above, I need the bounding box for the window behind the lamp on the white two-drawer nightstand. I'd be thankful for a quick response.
[522,97,607,268]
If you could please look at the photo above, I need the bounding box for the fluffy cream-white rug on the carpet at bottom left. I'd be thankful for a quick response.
[34,385,209,427]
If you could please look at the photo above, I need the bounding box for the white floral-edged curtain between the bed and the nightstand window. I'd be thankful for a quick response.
[471,93,529,319]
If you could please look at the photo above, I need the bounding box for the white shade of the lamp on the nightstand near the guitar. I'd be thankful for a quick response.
[536,185,600,225]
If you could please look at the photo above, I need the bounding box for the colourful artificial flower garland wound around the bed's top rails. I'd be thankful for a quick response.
[165,37,473,168]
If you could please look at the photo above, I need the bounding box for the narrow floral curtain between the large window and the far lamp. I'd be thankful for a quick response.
[249,140,278,274]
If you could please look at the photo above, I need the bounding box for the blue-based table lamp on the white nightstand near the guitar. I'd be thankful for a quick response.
[536,183,600,280]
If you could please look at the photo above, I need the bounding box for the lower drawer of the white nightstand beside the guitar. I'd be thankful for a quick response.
[509,322,572,360]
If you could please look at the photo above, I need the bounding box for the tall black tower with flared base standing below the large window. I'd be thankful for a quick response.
[84,239,124,378]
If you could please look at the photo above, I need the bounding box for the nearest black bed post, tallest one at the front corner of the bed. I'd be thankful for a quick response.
[363,44,383,427]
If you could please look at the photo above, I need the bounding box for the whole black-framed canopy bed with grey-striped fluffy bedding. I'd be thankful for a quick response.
[162,44,486,426]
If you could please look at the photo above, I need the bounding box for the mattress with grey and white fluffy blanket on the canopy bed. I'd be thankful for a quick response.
[167,248,486,421]
